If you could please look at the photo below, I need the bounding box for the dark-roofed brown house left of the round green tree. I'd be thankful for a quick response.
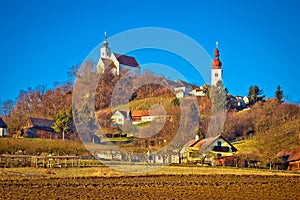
[20,117,61,139]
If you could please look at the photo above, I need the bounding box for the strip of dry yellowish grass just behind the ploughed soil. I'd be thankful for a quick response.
[0,165,300,180]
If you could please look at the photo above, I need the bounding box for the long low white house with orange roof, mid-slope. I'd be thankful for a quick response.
[131,110,166,124]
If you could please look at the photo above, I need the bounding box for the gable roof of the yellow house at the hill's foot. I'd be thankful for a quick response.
[185,134,237,151]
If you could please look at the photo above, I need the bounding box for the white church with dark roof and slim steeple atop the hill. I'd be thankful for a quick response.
[96,32,141,75]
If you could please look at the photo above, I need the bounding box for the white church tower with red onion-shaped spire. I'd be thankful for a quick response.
[211,41,223,86]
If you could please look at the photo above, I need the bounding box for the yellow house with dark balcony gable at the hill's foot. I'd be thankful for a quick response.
[180,134,237,165]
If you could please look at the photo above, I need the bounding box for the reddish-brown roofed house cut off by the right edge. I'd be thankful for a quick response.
[276,147,300,171]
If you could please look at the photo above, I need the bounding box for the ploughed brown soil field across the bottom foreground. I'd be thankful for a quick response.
[0,175,300,200]
